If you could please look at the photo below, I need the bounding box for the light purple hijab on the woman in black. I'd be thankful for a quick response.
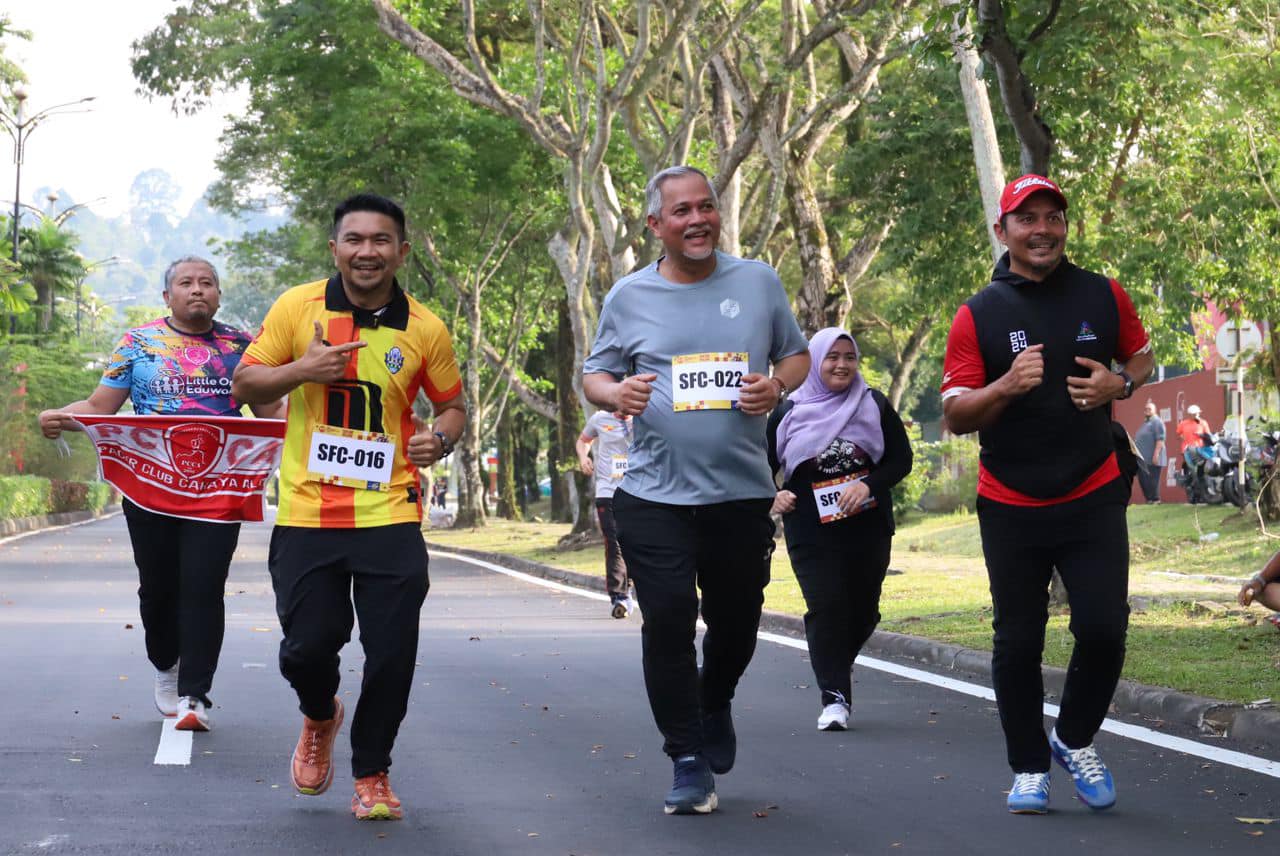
[778,328,884,481]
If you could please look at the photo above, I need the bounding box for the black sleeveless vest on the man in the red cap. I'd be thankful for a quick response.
[968,253,1120,499]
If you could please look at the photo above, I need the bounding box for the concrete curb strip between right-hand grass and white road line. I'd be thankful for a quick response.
[426,540,1280,760]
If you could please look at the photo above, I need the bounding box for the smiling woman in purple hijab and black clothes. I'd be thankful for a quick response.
[768,328,911,731]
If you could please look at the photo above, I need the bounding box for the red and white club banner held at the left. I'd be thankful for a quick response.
[76,413,285,523]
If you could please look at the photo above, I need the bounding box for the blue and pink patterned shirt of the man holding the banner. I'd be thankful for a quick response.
[101,319,250,416]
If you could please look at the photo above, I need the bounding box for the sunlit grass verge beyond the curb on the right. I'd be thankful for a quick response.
[426,505,1280,702]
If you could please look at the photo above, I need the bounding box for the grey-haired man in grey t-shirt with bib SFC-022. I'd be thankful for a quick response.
[582,166,809,814]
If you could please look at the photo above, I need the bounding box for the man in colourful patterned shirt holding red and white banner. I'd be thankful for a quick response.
[40,256,283,731]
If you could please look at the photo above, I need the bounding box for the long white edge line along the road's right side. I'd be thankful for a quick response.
[431,550,1280,779]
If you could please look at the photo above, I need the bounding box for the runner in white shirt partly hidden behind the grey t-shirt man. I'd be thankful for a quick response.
[573,411,631,618]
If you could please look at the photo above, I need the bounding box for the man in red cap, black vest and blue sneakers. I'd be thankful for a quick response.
[942,175,1153,814]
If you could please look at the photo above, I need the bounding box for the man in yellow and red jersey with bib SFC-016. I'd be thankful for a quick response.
[232,194,466,819]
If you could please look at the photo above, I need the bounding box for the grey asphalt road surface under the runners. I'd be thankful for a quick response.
[0,517,1280,856]
